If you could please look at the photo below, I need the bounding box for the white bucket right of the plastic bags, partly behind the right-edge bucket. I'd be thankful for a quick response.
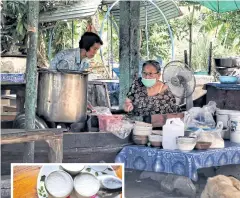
[216,109,240,139]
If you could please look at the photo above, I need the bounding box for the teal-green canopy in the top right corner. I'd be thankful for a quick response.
[194,0,240,13]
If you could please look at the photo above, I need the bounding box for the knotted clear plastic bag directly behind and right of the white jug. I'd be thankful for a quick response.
[184,101,217,129]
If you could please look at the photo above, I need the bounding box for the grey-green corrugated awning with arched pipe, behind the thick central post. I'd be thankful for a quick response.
[102,0,182,26]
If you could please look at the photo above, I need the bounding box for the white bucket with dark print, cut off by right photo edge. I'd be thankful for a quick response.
[229,114,240,143]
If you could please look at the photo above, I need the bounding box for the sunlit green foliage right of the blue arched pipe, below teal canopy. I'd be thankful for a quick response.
[171,4,240,71]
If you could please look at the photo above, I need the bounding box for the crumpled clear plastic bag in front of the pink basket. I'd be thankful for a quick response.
[106,120,134,139]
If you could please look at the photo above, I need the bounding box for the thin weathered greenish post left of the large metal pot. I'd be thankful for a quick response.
[23,1,39,163]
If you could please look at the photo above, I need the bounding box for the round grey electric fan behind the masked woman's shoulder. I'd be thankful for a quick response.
[163,61,196,110]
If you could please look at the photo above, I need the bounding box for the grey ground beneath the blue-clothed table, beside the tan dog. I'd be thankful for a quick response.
[125,165,240,198]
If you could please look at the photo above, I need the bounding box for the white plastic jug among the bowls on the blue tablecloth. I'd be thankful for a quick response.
[162,118,184,150]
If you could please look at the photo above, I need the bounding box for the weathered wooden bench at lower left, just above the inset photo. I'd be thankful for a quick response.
[1,129,66,163]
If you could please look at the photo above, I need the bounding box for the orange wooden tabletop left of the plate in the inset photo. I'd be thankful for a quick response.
[13,166,42,198]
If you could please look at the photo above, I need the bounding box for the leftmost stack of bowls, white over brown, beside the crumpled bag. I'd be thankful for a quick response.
[133,122,152,145]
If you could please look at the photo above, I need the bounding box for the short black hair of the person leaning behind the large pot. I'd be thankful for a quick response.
[79,32,103,51]
